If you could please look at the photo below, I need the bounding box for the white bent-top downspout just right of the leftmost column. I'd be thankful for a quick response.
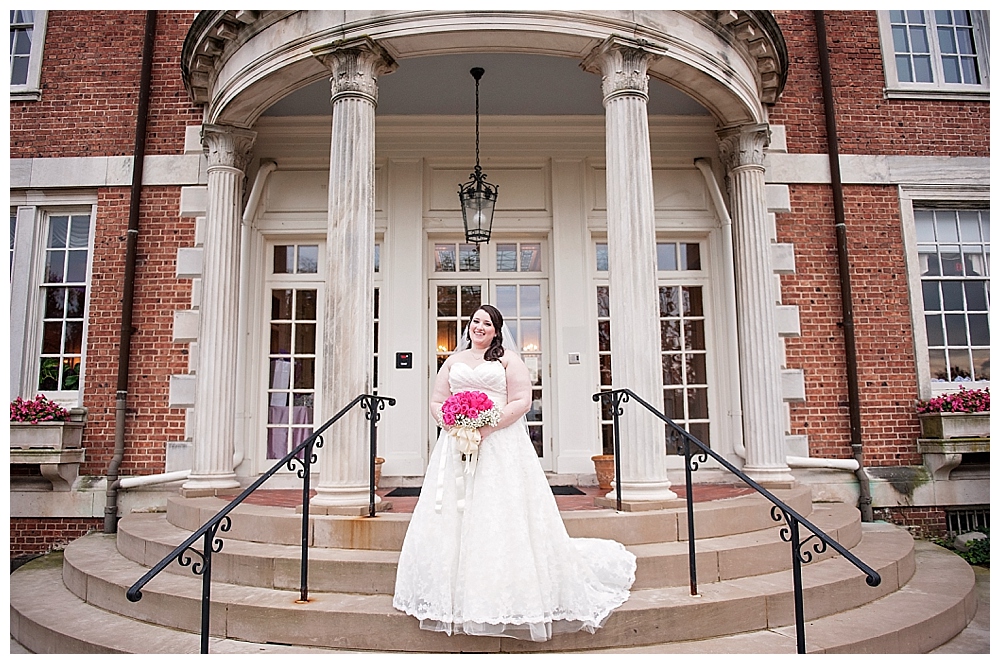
[233,159,278,471]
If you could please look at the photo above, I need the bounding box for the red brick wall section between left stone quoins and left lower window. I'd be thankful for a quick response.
[81,187,194,475]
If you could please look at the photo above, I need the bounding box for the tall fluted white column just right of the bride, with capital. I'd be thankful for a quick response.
[582,37,677,501]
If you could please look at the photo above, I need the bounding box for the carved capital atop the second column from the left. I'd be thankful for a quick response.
[312,37,399,104]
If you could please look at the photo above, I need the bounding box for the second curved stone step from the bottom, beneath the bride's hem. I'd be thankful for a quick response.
[45,527,913,652]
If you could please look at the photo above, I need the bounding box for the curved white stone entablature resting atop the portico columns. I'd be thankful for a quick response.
[182,11,787,128]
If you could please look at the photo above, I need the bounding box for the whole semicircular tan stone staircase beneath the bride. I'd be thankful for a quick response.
[11,487,977,653]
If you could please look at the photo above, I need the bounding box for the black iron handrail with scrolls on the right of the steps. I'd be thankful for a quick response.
[593,388,882,654]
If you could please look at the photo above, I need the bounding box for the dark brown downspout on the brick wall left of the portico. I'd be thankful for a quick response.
[104,10,156,533]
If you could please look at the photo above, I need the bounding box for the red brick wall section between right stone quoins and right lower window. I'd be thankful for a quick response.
[777,185,922,466]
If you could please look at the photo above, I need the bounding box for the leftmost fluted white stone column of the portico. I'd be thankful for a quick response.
[183,125,257,495]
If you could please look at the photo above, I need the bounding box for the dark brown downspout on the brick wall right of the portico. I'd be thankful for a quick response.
[813,10,874,522]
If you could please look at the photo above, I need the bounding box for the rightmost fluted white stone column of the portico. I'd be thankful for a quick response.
[719,124,794,483]
